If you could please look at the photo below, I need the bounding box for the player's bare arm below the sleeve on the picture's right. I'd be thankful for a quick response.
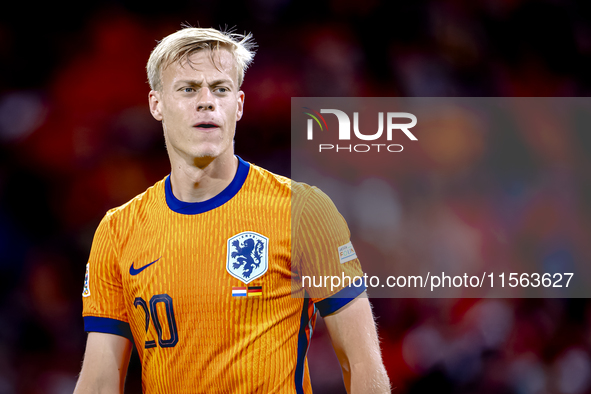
[324,296,390,394]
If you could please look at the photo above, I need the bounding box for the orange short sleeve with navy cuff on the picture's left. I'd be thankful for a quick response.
[82,214,132,340]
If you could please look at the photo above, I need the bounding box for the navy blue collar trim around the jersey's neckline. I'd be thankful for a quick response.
[164,156,250,215]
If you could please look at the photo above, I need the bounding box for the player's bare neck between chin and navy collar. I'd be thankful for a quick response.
[170,154,238,202]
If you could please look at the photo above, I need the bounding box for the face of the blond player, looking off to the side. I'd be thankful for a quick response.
[149,46,244,166]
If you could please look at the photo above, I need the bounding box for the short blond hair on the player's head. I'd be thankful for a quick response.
[146,27,256,90]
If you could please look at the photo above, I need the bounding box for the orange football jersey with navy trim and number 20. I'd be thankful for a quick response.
[83,158,365,394]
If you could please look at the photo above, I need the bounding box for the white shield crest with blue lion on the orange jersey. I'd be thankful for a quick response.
[226,231,269,284]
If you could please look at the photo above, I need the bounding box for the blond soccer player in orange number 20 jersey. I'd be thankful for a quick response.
[75,28,390,394]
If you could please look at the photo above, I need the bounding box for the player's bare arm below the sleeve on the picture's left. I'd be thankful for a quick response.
[74,332,132,394]
